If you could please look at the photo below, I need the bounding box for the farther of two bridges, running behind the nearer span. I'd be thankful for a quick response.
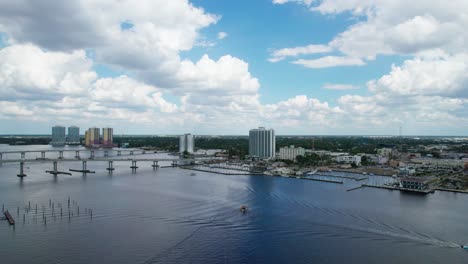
[0,149,163,162]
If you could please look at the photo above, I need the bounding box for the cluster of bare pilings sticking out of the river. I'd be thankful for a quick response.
[2,197,93,228]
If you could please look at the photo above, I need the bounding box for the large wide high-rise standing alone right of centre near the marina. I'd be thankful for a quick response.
[249,127,276,158]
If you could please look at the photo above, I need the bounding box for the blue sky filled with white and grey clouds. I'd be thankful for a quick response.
[0,0,468,136]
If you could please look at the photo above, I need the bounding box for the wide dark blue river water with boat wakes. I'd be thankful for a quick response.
[0,145,468,263]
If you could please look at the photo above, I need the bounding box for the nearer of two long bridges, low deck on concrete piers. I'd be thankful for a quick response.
[0,158,200,178]
